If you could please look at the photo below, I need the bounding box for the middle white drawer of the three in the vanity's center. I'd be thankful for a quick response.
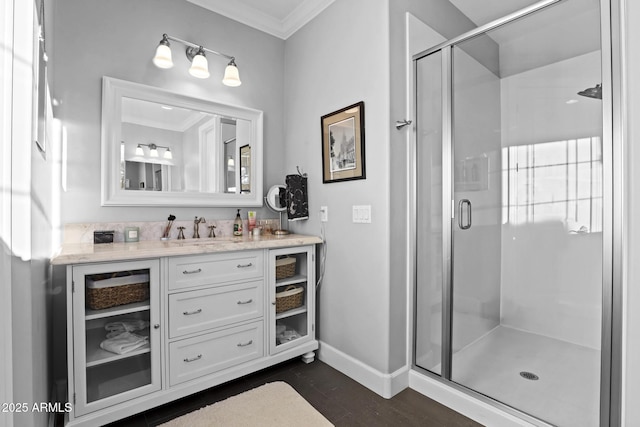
[169,280,264,338]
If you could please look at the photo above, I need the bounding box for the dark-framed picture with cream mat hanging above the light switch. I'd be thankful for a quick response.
[320,101,366,184]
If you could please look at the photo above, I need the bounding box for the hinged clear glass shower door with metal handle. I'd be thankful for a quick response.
[450,0,603,427]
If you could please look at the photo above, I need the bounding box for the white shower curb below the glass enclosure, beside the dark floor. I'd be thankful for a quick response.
[409,370,534,427]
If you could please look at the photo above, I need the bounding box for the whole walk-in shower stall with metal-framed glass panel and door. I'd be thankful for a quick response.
[413,0,613,427]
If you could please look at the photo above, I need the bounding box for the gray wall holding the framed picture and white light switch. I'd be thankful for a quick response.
[284,0,392,373]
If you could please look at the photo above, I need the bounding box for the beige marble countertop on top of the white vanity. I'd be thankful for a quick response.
[51,234,322,265]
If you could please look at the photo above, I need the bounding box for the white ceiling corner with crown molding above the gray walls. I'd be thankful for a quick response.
[187,0,334,40]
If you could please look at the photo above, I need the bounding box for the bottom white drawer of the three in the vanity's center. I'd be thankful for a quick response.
[169,321,264,386]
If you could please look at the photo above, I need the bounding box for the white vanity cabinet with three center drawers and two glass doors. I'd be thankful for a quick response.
[61,236,319,426]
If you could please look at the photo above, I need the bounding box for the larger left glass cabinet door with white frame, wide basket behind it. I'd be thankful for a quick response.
[71,260,161,416]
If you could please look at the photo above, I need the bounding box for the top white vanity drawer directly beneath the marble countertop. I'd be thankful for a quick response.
[169,251,264,290]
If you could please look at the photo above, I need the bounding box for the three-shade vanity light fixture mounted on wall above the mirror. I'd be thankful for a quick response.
[153,34,242,86]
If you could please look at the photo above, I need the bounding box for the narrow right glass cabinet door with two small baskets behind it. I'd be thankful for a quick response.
[269,246,315,354]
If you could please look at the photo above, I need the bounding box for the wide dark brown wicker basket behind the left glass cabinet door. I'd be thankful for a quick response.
[86,274,149,310]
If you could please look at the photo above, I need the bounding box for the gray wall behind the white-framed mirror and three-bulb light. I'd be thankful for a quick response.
[51,0,284,223]
